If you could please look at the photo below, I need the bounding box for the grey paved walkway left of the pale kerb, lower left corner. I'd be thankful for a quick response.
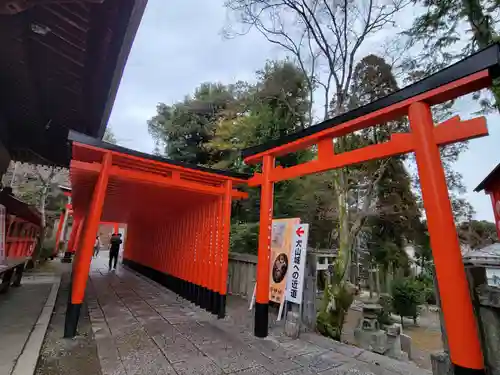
[0,272,55,375]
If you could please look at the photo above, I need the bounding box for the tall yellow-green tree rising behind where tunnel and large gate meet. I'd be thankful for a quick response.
[205,61,311,226]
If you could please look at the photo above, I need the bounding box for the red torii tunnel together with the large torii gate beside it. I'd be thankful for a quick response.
[60,45,500,374]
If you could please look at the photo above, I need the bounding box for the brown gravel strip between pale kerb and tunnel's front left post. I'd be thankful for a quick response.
[35,259,101,375]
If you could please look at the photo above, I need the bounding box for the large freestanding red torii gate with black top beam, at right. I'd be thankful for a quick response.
[243,45,500,374]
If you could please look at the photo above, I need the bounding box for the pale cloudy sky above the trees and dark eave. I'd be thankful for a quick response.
[109,0,500,221]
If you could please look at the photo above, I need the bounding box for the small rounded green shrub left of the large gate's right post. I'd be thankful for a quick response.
[392,278,423,324]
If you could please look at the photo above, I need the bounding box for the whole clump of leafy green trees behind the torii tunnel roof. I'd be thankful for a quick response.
[148,61,313,247]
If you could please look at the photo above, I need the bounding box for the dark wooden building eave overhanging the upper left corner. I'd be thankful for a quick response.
[0,0,147,166]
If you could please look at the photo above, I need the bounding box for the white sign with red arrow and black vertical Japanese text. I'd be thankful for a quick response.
[286,224,309,305]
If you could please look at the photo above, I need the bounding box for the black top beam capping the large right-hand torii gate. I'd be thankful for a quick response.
[242,44,500,158]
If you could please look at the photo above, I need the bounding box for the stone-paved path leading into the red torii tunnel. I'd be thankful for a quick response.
[87,255,429,375]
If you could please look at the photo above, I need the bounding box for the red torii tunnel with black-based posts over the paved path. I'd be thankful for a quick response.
[64,132,249,337]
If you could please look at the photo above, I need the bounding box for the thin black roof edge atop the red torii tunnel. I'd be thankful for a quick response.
[68,131,251,180]
